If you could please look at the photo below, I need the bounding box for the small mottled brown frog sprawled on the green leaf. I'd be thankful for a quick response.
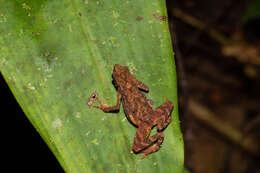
[89,64,173,159]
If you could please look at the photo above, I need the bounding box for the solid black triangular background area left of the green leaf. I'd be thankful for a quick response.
[0,75,64,173]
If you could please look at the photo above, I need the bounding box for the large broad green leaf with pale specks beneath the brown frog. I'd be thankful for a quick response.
[0,0,183,173]
